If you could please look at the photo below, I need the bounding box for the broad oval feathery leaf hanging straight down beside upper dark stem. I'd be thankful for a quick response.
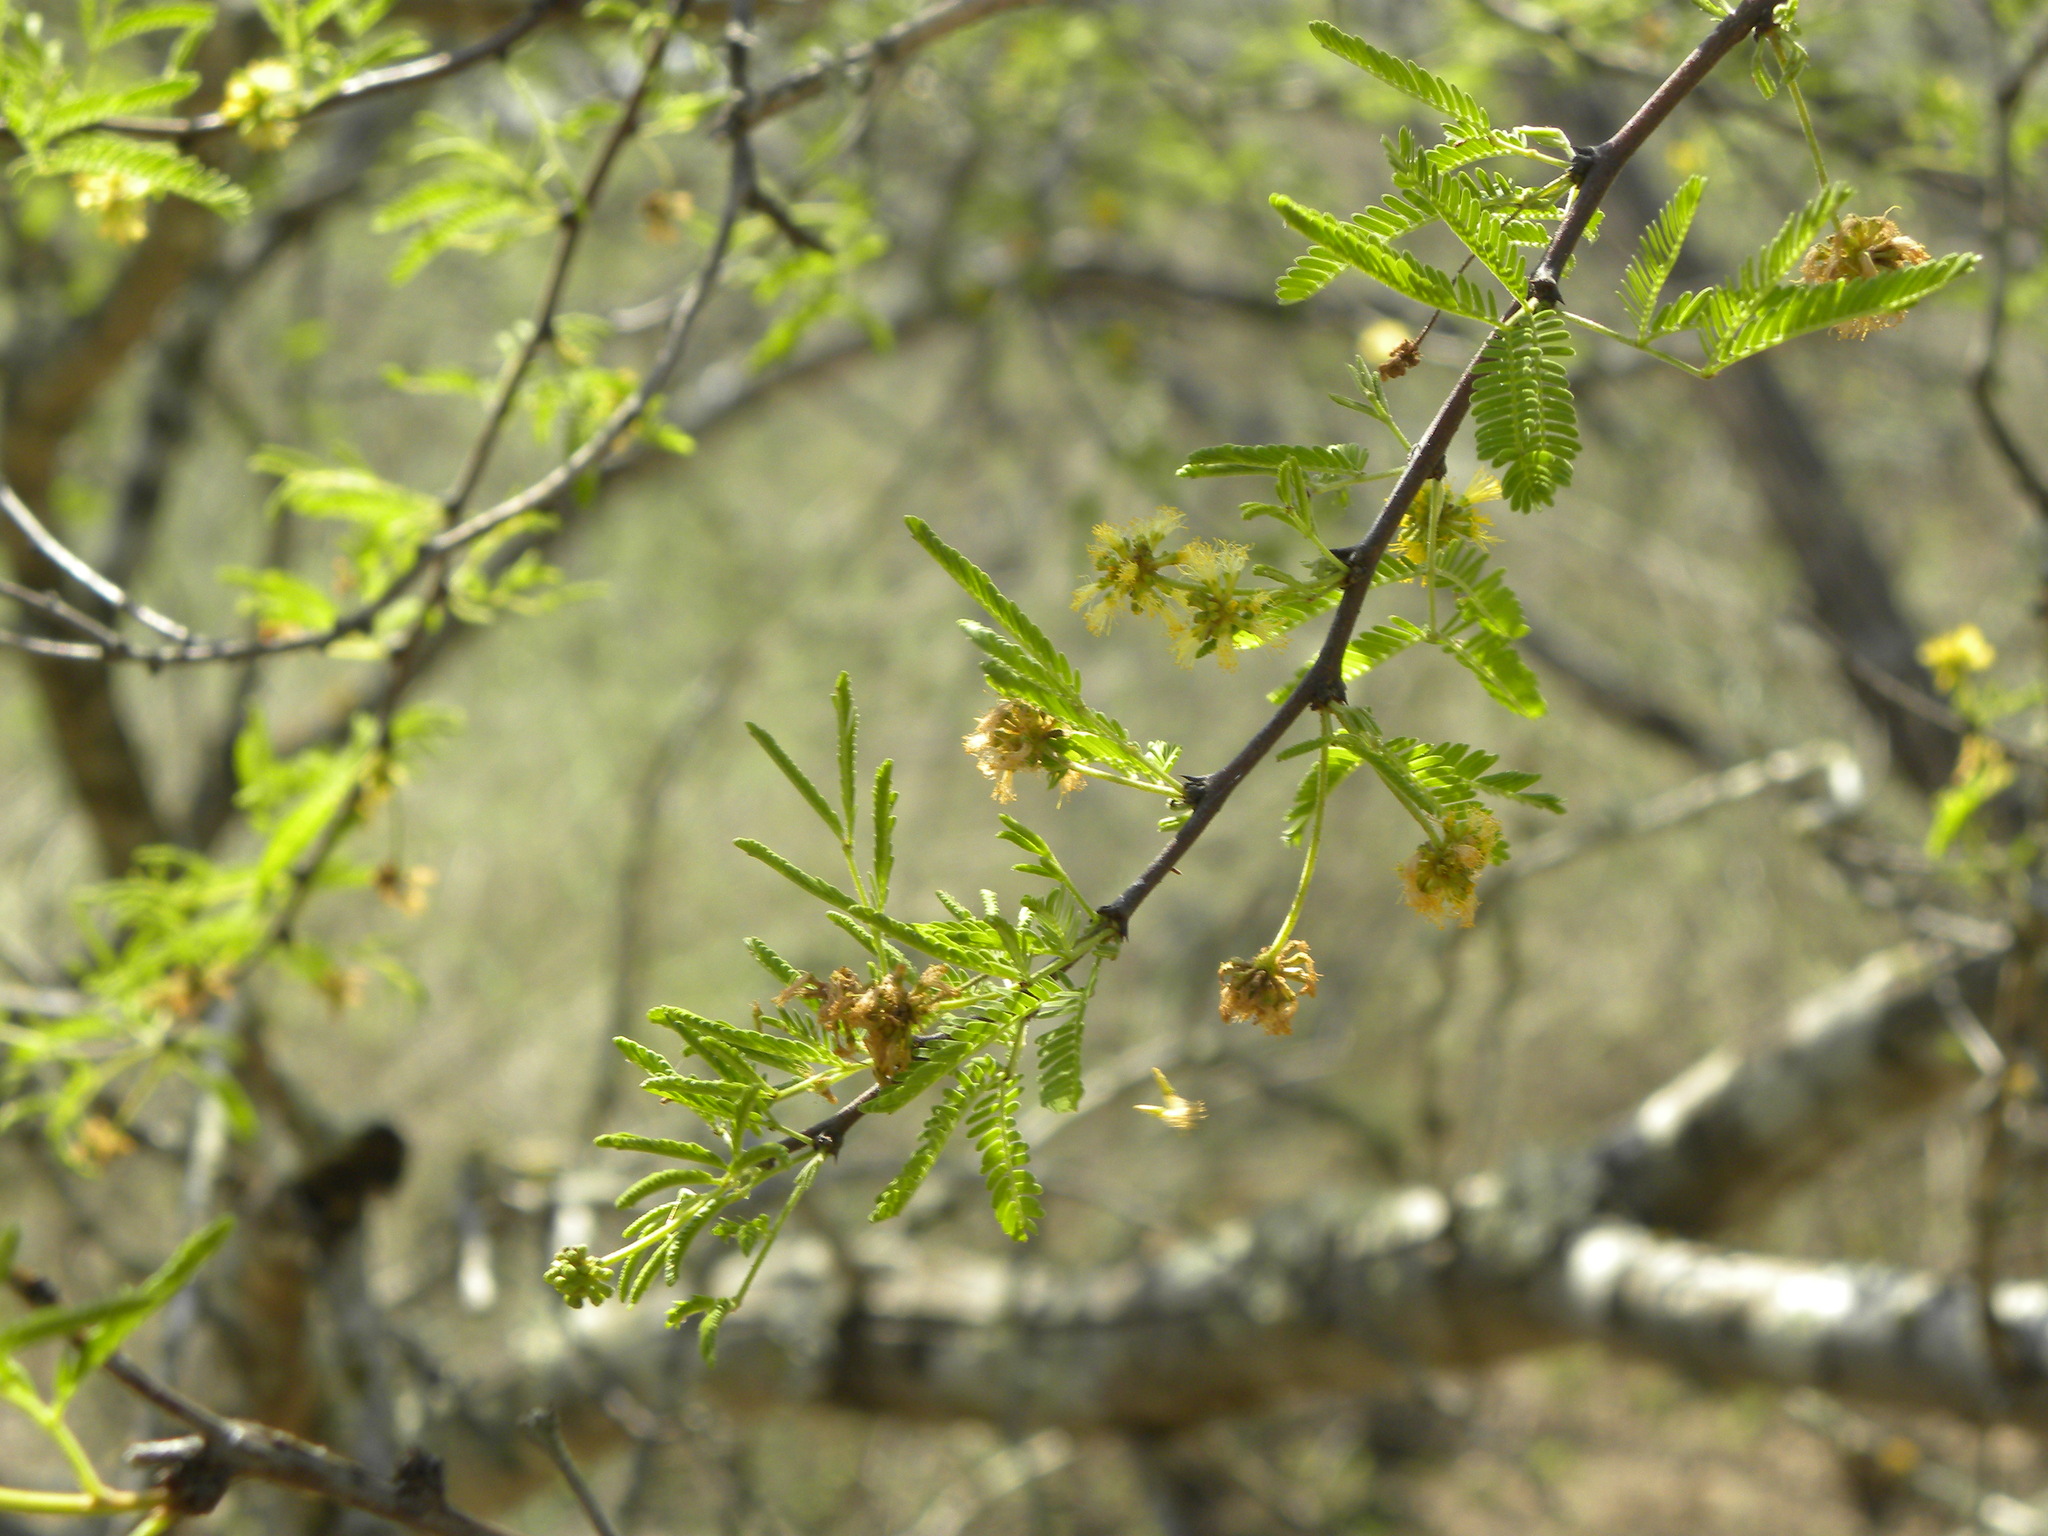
[1473,309,1579,512]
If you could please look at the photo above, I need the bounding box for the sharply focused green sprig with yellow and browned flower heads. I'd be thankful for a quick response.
[571,0,1974,1352]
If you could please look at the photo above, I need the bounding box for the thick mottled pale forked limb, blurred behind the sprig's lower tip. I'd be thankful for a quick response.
[352,946,2015,1509]
